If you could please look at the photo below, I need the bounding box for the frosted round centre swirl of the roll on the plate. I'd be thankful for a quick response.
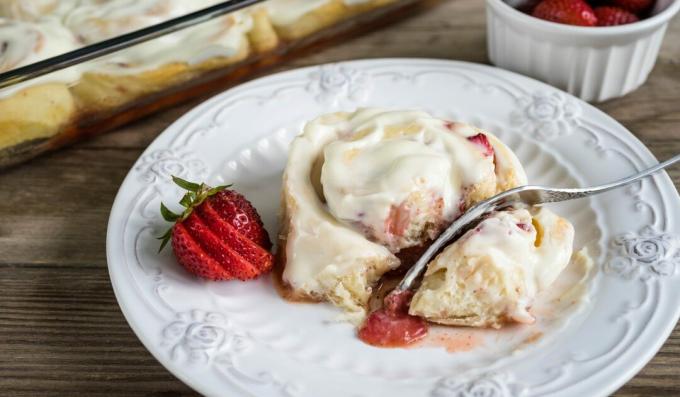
[321,109,495,250]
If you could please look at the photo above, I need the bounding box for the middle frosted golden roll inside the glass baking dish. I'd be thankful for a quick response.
[66,0,258,110]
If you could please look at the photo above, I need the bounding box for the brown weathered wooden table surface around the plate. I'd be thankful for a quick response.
[0,0,680,396]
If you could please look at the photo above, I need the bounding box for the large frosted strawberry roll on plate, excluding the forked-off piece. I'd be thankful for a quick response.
[279,109,526,320]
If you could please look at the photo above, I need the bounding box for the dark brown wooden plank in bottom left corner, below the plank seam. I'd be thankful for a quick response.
[0,261,194,396]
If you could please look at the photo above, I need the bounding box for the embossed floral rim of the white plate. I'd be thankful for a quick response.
[107,59,680,397]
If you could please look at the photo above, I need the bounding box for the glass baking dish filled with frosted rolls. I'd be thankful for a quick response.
[0,0,437,168]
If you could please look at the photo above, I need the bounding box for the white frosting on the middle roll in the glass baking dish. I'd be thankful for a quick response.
[64,0,252,74]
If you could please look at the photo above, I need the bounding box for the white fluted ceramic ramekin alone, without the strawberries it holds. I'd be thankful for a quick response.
[486,0,680,102]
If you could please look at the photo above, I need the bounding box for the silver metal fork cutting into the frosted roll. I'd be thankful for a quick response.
[391,154,680,293]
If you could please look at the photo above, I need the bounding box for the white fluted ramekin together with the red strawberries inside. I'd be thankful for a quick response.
[486,0,680,102]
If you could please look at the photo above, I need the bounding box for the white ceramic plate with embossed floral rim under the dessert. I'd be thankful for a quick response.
[107,59,680,397]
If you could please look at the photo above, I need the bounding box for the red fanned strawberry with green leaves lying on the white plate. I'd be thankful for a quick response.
[159,176,274,280]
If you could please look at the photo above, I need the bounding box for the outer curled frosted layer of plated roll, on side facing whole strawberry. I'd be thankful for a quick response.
[281,113,399,311]
